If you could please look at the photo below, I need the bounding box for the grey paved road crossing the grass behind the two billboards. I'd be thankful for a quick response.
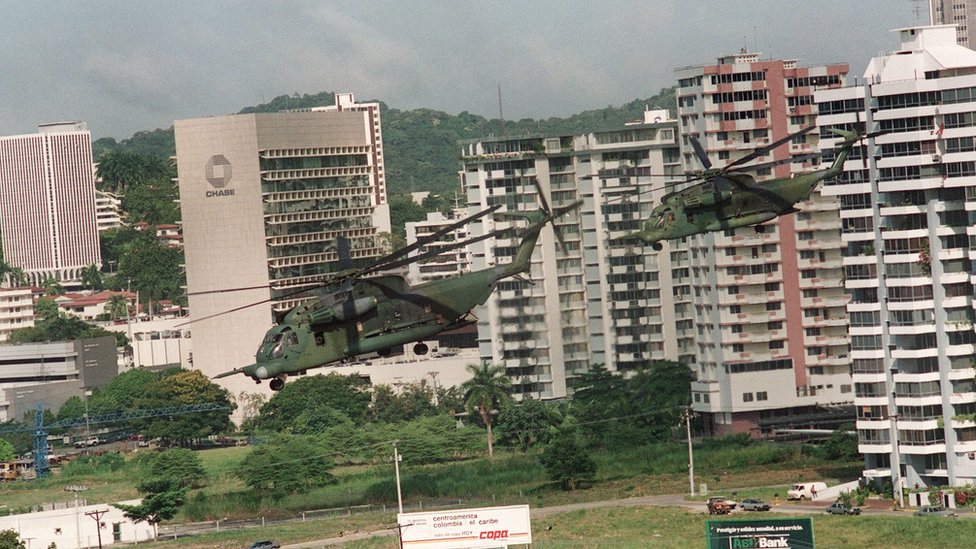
[282,494,960,549]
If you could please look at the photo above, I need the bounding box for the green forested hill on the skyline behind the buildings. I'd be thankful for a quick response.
[93,88,675,196]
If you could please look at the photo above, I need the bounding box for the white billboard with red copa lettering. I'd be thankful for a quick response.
[397,505,532,549]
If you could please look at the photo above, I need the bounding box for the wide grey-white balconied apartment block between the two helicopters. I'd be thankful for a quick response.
[461,111,691,399]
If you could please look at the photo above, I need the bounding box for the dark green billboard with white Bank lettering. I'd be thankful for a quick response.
[705,518,814,549]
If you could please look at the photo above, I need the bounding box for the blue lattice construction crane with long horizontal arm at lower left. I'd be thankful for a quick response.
[0,402,230,478]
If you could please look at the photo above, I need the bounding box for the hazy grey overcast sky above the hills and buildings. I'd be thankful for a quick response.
[0,0,928,139]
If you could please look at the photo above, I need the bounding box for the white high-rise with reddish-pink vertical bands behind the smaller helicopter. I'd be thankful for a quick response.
[680,51,854,435]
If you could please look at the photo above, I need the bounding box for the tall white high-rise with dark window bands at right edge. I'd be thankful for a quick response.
[815,25,976,486]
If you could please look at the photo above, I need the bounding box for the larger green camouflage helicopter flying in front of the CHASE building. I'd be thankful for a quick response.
[214,193,582,391]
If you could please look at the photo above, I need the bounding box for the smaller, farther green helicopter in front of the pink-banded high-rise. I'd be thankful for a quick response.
[627,126,860,250]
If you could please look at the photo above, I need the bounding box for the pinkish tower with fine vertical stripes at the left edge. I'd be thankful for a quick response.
[0,122,102,285]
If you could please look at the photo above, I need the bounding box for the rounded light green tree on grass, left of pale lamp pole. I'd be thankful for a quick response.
[237,436,336,499]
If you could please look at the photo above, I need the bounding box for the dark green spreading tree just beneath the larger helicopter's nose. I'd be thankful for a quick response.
[256,373,370,433]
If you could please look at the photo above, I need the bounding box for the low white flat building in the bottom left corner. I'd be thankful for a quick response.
[0,500,153,549]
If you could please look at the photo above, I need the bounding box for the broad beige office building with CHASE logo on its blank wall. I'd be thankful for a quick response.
[175,95,390,390]
